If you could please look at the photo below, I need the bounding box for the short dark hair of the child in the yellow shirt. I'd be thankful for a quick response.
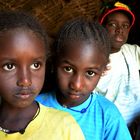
[0,10,49,53]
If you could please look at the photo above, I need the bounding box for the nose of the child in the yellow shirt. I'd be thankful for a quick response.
[17,68,32,87]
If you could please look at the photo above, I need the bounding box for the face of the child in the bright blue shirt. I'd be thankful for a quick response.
[57,41,107,106]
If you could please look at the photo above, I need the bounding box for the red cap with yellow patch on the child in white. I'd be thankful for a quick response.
[99,2,135,28]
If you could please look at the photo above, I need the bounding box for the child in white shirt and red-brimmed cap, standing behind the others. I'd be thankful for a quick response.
[96,2,140,134]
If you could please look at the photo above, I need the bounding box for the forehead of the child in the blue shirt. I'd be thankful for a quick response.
[58,41,106,63]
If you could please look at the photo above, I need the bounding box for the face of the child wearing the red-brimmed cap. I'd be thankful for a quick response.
[106,12,130,51]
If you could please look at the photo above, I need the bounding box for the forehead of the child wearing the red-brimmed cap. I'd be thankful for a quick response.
[107,11,130,23]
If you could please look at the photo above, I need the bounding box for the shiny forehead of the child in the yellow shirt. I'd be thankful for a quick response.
[0,29,45,55]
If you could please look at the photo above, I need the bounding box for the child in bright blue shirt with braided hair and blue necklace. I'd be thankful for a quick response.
[36,20,131,140]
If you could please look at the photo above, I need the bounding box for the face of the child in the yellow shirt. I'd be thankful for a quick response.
[0,29,46,107]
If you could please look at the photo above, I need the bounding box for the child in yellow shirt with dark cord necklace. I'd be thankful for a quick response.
[0,12,84,140]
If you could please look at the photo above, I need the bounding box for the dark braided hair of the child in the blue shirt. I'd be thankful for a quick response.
[44,18,110,91]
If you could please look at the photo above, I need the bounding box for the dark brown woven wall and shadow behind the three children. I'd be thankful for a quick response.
[0,0,140,46]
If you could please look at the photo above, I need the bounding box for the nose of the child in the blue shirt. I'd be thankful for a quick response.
[70,75,84,92]
